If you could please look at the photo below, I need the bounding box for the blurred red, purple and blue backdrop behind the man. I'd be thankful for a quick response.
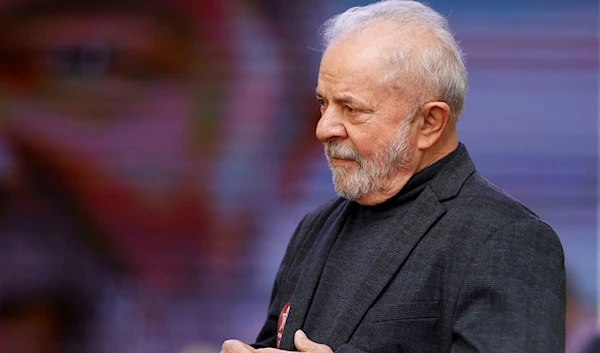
[0,0,600,353]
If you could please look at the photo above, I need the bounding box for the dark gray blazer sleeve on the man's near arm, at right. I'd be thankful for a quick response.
[451,219,566,353]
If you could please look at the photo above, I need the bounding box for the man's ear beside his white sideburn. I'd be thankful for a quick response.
[417,102,451,150]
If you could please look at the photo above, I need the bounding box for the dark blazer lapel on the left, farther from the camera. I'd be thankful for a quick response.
[281,202,350,350]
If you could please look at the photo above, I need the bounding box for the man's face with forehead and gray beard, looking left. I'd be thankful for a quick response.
[317,27,415,200]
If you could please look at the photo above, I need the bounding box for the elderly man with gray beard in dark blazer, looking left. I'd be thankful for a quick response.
[222,0,565,353]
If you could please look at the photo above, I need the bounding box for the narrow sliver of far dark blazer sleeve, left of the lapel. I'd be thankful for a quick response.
[251,216,308,348]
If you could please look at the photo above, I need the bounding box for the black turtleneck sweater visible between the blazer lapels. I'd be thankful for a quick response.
[304,146,456,342]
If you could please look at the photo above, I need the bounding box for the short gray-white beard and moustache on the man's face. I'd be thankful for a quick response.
[324,119,414,200]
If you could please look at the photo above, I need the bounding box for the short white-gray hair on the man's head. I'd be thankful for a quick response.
[321,0,467,121]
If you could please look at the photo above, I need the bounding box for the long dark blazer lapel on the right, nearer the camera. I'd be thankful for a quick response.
[326,188,445,349]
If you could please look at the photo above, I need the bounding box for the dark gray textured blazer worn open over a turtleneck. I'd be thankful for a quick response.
[255,145,566,353]
